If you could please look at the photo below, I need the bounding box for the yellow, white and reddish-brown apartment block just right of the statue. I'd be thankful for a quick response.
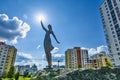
[65,47,88,69]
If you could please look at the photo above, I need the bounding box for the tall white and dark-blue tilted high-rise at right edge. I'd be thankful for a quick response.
[100,0,120,67]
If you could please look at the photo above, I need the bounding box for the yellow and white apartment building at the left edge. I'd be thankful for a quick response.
[0,42,17,77]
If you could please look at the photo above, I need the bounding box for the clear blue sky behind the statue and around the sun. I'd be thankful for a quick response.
[0,0,106,69]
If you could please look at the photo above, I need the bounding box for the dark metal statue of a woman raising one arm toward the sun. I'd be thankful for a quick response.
[41,21,60,68]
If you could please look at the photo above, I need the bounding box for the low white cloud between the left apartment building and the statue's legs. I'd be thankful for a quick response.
[15,52,47,69]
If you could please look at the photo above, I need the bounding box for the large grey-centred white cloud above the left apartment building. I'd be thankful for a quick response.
[0,14,30,44]
